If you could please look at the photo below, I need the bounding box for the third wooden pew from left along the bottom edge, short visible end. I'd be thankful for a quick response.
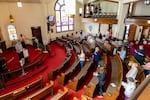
[51,87,68,100]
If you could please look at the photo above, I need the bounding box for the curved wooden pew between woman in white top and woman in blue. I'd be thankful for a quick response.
[69,59,92,91]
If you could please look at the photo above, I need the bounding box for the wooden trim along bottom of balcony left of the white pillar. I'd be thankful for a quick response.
[82,18,118,24]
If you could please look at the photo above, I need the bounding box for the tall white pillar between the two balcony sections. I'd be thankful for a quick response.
[115,0,129,39]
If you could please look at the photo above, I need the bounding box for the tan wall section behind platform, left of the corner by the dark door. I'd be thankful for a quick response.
[0,3,42,47]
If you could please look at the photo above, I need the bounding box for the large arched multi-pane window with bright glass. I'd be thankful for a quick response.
[55,0,75,32]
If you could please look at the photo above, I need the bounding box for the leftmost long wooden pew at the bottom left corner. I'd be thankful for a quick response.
[0,76,43,100]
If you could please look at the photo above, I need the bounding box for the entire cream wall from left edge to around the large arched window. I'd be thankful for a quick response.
[0,0,83,47]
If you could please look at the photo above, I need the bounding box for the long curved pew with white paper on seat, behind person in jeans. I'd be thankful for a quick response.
[103,55,123,100]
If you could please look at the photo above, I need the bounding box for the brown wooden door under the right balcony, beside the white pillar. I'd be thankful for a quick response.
[128,25,137,42]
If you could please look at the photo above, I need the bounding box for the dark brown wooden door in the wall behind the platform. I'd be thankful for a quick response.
[31,26,42,43]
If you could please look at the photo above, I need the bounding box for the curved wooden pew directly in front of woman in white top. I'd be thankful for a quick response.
[57,58,80,85]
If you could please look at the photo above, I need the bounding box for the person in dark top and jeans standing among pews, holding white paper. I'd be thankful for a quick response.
[93,66,106,98]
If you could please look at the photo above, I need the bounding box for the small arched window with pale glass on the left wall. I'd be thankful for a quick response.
[8,25,18,41]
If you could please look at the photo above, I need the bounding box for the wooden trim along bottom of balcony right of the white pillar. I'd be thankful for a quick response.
[125,18,150,26]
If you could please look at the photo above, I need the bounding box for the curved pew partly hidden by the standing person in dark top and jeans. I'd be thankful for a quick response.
[83,54,108,98]
